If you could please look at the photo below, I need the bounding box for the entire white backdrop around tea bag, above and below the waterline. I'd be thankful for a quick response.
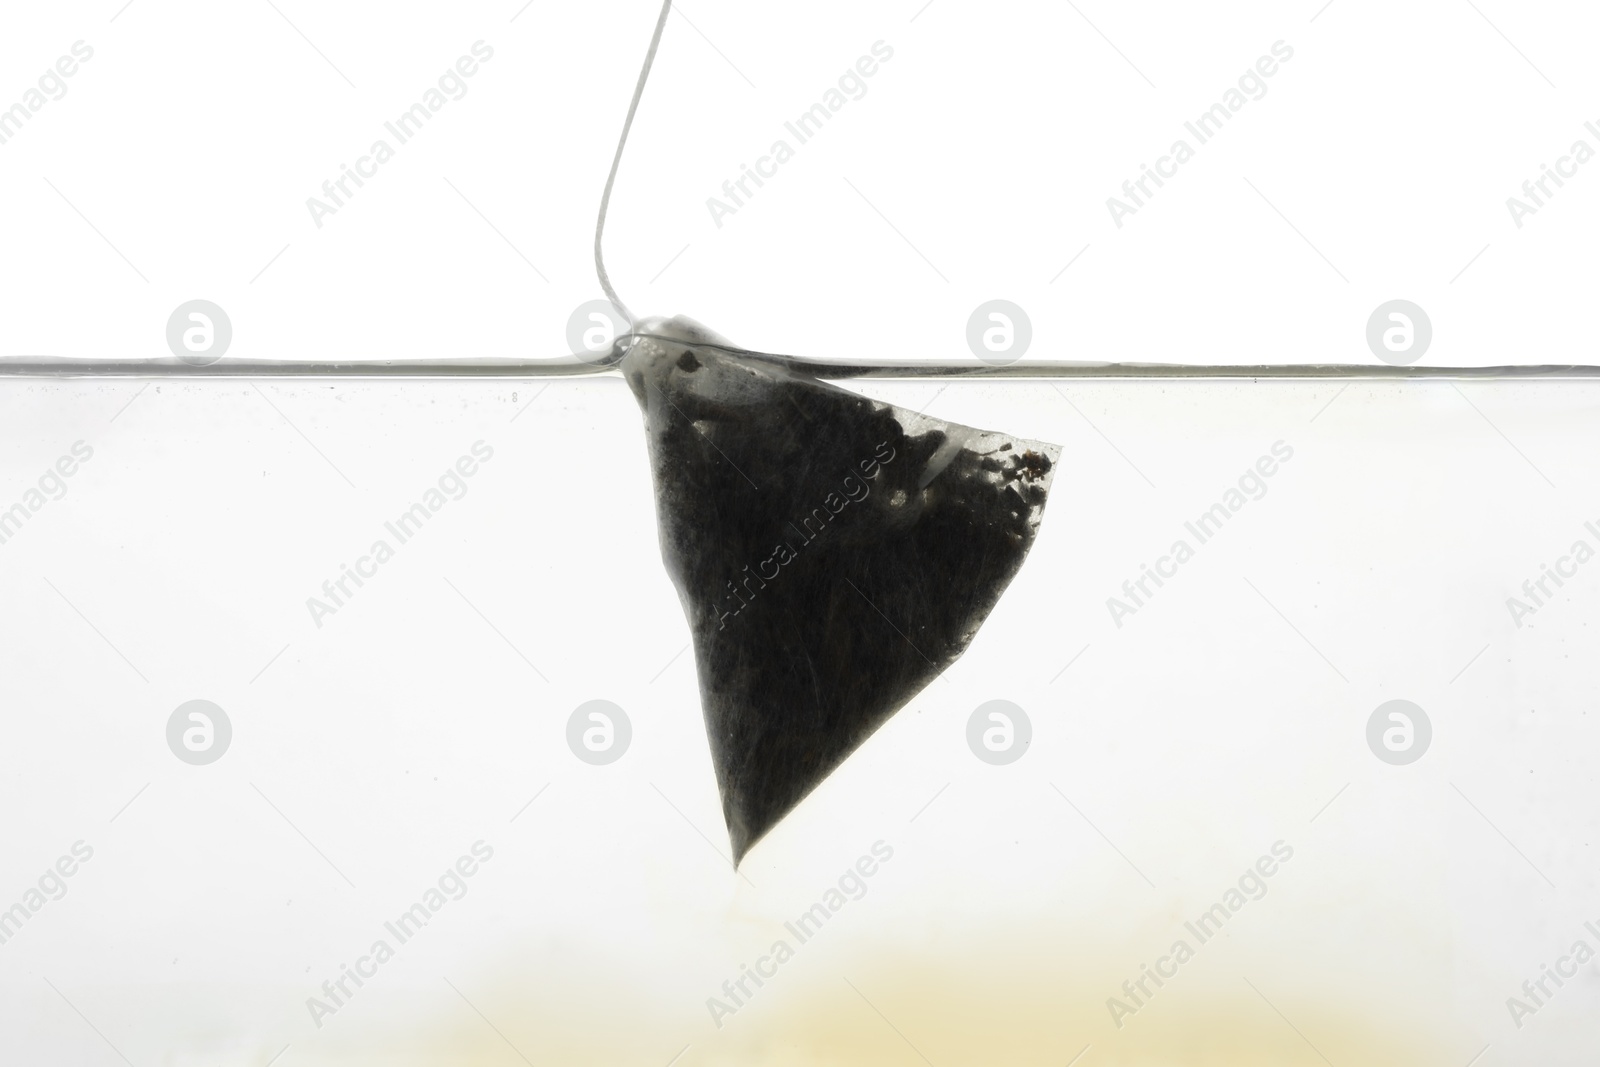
[0,0,1600,1067]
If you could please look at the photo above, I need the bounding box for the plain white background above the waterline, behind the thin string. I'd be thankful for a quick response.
[0,0,1600,365]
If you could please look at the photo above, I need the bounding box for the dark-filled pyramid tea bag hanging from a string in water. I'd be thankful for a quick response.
[621,318,1059,864]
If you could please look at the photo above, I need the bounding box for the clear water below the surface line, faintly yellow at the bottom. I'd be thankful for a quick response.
[0,365,1600,1067]
